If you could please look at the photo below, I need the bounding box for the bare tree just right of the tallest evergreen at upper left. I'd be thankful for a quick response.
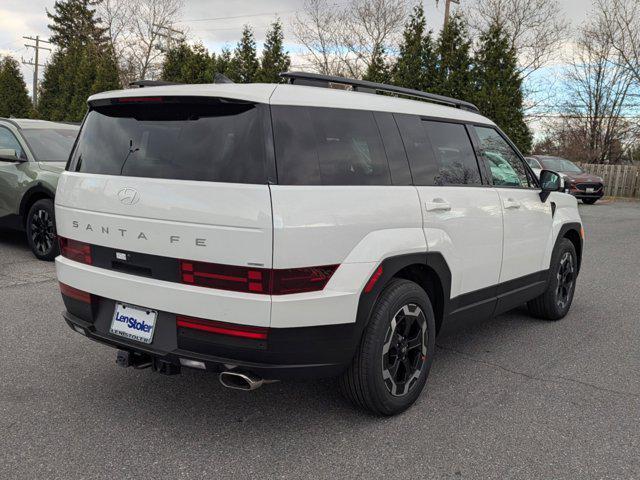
[98,0,184,85]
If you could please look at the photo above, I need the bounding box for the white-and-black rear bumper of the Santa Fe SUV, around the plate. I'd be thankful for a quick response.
[56,251,375,379]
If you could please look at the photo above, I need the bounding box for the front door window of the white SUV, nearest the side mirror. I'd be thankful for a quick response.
[474,127,531,188]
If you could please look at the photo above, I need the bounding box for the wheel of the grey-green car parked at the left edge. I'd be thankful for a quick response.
[26,198,58,261]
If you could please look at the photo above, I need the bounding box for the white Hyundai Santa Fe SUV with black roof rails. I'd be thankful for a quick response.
[56,73,583,415]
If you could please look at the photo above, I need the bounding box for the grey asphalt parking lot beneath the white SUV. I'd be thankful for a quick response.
[0,202,640,479]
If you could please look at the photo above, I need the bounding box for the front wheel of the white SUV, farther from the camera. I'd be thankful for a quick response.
[527,238,578,320]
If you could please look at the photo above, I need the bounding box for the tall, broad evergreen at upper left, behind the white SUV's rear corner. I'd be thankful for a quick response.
[38,0,120,122]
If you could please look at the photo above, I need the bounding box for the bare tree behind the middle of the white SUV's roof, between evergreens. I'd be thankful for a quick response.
[292,0,410,77]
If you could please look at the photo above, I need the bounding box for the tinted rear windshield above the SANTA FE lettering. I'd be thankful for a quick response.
[72,102,267,184]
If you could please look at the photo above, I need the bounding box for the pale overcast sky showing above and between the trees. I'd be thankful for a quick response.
[0,0,591,97]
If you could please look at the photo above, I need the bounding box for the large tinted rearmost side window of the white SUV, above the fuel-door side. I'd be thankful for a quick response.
[272,106,391,185]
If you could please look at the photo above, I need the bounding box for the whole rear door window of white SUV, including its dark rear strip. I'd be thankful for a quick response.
[395,115,482,185]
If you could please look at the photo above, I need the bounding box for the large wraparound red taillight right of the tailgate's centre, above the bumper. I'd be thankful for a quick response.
[180,260,338,295]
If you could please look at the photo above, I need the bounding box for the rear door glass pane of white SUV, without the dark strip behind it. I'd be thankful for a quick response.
[422,121,482,185]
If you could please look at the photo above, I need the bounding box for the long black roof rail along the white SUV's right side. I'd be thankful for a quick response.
[280,72,480,113]
